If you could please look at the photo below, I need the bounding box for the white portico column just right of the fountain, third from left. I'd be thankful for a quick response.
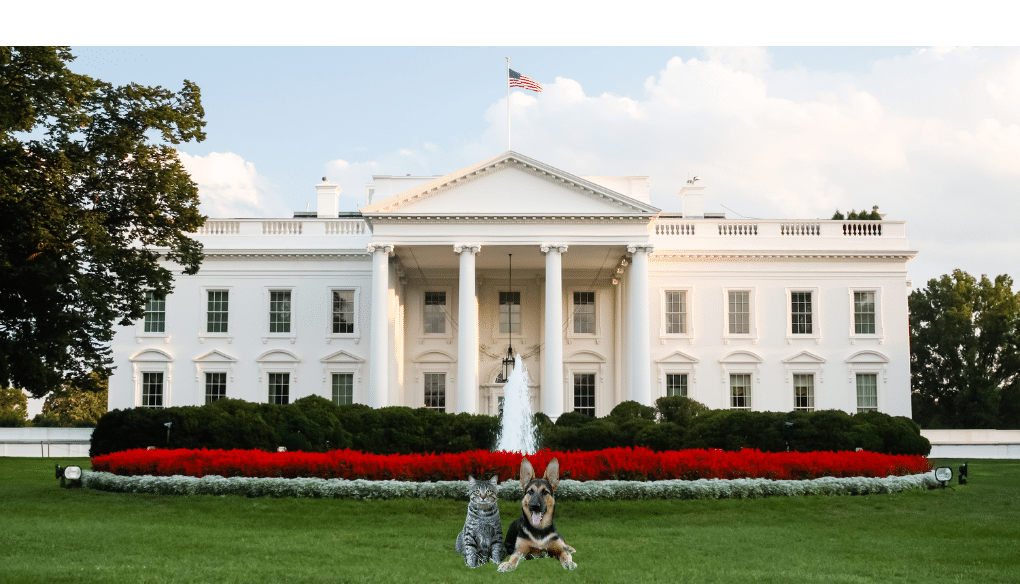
[541,245,567,420]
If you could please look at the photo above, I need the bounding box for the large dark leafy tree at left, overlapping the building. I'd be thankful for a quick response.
[0,47,205,396]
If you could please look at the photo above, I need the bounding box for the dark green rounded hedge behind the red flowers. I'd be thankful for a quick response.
[89,395,931,457]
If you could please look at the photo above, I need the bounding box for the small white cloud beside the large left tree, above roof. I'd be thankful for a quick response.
[177,152,292,217]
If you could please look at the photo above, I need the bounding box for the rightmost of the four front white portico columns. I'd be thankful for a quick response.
[625,245,653,406]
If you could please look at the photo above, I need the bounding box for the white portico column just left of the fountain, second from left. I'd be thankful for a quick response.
[453,245,481,414]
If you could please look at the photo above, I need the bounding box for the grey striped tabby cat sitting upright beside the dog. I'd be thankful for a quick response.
[454,477,503,568]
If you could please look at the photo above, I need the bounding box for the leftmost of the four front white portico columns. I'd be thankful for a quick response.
[368,244,393,408]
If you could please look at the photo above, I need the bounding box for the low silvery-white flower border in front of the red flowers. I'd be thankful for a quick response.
[82,471,939,500]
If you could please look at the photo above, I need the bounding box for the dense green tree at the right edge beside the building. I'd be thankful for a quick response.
[910,270,1020,428]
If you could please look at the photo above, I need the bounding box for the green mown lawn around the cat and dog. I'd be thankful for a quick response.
[0,458,1020,584]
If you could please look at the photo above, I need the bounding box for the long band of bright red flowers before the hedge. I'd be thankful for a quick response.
[92,447,930,481]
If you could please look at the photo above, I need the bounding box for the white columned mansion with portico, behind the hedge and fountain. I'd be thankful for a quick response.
[109,152,916,419]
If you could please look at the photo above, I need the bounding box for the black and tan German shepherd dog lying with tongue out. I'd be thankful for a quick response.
[499,459,577,572]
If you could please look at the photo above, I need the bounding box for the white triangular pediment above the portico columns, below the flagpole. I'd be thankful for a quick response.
[361,151,659,220]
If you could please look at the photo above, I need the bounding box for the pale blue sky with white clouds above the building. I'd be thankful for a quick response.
[63,46,1020,288]
